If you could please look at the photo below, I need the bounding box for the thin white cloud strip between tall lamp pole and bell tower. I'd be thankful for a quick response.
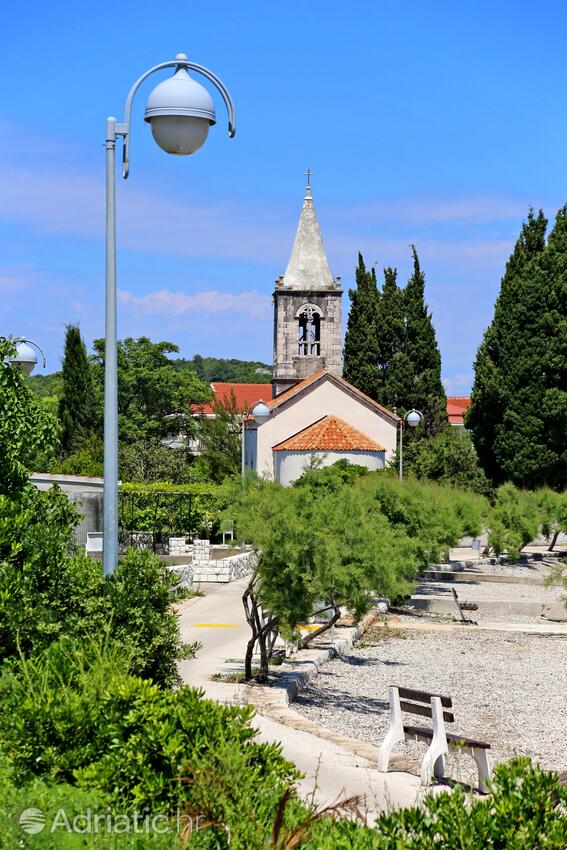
[118,289,272,319]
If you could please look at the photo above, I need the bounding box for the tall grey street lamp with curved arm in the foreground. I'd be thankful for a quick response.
[103,53,236,575]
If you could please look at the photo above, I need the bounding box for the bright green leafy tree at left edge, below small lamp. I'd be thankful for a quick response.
[0,337,58,486]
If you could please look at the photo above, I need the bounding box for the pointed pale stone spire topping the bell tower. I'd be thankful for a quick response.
[281,185,335,290]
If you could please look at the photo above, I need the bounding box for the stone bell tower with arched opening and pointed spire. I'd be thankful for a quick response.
[272,180,343,396]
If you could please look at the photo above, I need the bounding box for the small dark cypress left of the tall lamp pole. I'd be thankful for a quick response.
[59,325,96,455]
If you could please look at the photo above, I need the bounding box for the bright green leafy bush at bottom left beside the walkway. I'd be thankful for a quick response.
[0,638,296,813]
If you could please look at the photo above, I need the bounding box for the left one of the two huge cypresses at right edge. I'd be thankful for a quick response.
[466,210,552,484]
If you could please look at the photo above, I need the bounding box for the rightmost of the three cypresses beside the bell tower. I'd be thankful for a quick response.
[404,245,447,436]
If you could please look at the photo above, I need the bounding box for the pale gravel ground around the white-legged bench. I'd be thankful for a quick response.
[294,630,567,782]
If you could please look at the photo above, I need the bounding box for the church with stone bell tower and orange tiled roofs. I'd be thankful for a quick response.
[197,182,399,485]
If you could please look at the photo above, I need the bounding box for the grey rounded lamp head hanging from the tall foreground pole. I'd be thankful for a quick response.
[144,53,216,156]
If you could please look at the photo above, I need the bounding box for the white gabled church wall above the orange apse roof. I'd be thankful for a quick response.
[256,378,397,478]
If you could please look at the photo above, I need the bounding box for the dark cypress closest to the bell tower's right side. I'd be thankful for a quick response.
[343,253,378,399]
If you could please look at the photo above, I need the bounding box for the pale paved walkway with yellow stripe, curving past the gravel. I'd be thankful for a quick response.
[179,579,422,819]
